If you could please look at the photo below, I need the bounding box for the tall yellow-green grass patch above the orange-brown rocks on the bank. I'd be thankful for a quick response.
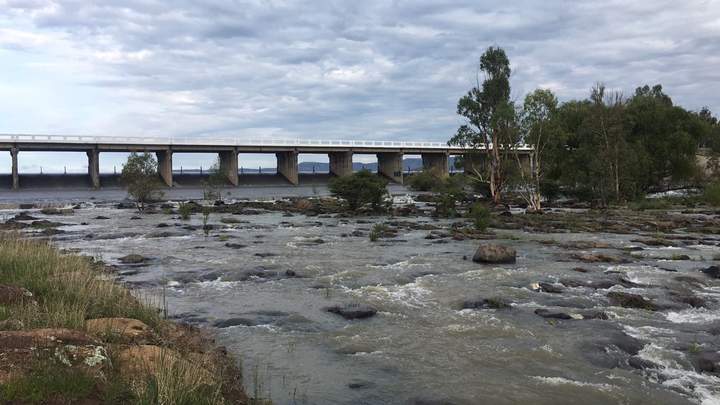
[0,234,162,330]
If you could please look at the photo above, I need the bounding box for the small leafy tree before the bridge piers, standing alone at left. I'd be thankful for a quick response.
[120,152,163,212]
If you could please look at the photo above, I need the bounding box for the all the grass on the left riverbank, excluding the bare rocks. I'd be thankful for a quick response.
[0,233,245,404]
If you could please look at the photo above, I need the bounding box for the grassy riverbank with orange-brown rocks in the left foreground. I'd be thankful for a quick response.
[0,233,248,404]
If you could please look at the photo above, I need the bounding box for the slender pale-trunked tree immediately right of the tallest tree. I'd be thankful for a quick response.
[515,89,563,211]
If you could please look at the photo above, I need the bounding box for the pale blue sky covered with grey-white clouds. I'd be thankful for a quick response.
[0,0,720,173]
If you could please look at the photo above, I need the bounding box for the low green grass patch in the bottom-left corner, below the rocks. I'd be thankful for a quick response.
[0,364,95,403]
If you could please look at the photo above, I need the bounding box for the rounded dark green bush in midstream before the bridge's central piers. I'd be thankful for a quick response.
[329,170,388,211]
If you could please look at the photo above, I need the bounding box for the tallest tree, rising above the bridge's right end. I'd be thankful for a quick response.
[448,47,517,204]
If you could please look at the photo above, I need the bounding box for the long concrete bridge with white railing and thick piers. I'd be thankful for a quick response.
[0,134,533,190]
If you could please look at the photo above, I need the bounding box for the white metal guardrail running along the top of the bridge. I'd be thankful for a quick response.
[0,134,532,150]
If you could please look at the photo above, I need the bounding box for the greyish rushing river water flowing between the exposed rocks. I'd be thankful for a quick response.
[1,200,720,405]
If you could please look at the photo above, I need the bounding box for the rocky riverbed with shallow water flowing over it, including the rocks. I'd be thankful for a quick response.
[2,196,720,404]
